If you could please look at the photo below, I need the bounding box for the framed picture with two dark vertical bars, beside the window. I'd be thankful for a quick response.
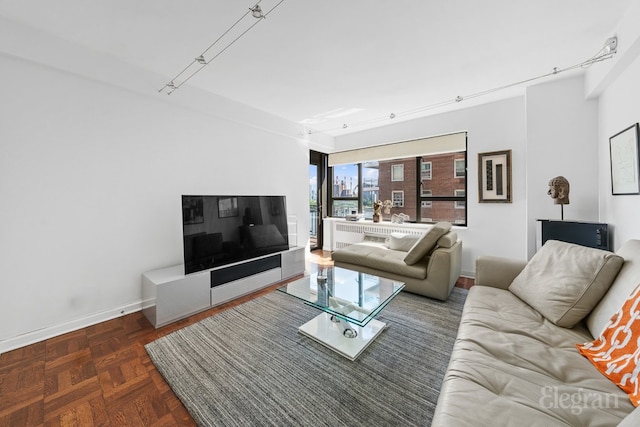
[478,150,511,203]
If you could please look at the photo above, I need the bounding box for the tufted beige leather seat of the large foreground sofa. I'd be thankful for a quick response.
[432,285,633,427]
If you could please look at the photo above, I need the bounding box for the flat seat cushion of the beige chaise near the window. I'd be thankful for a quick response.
[332,243,427,279]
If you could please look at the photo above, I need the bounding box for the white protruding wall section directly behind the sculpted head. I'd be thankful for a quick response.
[527,76,599,257]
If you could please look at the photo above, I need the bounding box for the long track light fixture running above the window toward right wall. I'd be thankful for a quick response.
[307,36,618,135]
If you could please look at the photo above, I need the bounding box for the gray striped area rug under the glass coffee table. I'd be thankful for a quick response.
[146,288,467,427]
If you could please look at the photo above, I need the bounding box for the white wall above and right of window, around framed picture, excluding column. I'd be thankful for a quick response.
[335,97,527,276]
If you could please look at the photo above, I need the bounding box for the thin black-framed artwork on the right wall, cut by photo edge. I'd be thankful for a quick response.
[609,123,640,196]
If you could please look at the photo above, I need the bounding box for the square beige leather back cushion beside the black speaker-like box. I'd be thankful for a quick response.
[509,240,624,328]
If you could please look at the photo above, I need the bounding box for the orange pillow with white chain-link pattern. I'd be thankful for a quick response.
[576,285,640,406]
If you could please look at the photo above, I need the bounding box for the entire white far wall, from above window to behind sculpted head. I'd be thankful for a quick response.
[335,76,598,276]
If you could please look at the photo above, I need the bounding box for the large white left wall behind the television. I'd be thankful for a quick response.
[0,20,309,352]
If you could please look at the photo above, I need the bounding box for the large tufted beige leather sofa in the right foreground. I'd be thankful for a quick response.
[432,240,640,427]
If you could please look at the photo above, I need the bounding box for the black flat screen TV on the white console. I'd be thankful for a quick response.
[182,195,289,274]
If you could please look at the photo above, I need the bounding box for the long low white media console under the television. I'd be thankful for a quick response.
[142,247,305,328]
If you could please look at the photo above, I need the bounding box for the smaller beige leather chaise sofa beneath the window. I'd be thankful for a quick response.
[332,222,462,300]
